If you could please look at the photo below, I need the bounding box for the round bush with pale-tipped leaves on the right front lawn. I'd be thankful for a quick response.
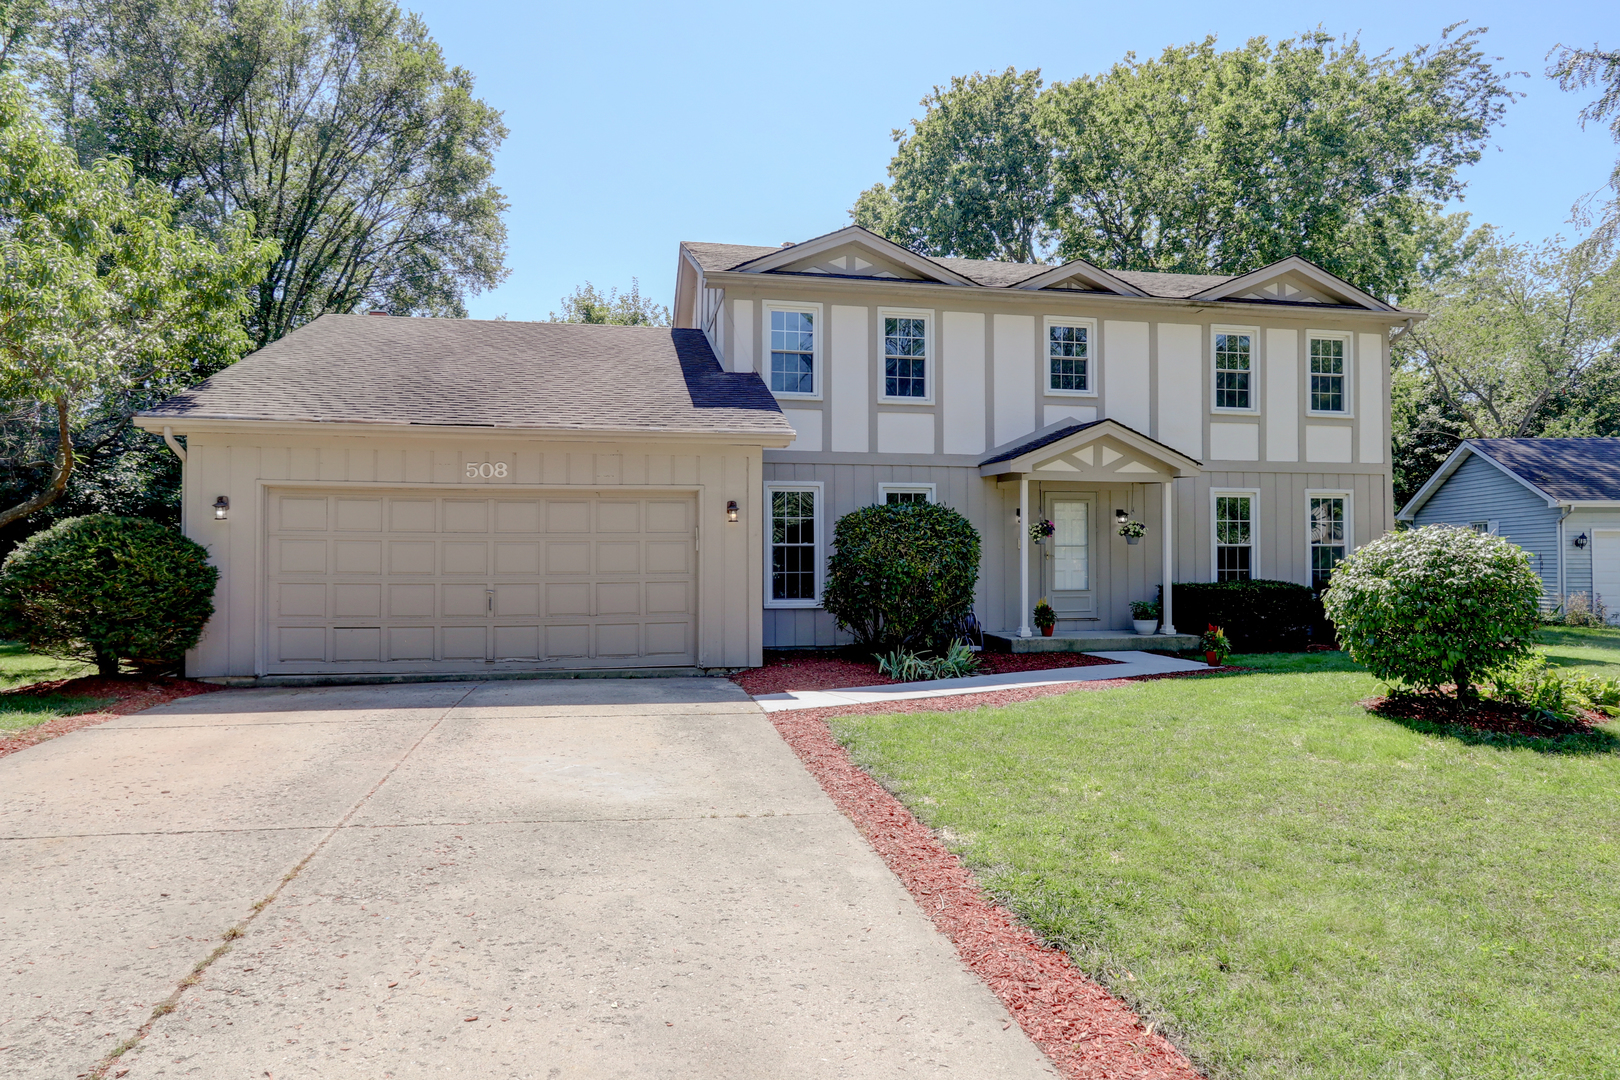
[1322,525,1542,701]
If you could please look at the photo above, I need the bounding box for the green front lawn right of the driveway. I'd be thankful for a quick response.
[833,630,1620,1080]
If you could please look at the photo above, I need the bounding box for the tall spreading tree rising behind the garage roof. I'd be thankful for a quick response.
[31,0,505,347]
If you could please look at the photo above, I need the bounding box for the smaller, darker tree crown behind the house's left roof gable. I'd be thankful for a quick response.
[851,68,1051,262]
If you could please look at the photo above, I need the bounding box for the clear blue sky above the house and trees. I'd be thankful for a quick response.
[403,0,1620,319]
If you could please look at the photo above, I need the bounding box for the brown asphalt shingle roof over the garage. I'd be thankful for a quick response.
[143,314,792,437]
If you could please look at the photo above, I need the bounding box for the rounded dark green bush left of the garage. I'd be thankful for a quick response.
[0,513,219,675]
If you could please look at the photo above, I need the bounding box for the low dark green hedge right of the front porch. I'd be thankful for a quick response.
[1170,578,1322,653]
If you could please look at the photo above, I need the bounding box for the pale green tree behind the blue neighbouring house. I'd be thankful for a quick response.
[1395,230,1620,439]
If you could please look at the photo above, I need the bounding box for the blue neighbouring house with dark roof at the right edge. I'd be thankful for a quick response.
[1395,439,1620,617]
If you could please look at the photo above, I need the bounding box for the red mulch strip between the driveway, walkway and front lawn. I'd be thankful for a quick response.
[771,709,1200,1080]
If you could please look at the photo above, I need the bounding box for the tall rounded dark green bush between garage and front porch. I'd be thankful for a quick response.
[821,502,978,653]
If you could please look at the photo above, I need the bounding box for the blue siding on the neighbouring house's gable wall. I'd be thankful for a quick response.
[1413,453,1561,606]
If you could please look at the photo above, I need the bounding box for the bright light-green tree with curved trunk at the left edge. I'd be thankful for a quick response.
[0,78,275,528]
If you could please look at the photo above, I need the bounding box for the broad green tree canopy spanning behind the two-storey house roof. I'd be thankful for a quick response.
[852,28,1513,296]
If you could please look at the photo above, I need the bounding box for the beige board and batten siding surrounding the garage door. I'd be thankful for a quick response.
[174,431,763,677]
